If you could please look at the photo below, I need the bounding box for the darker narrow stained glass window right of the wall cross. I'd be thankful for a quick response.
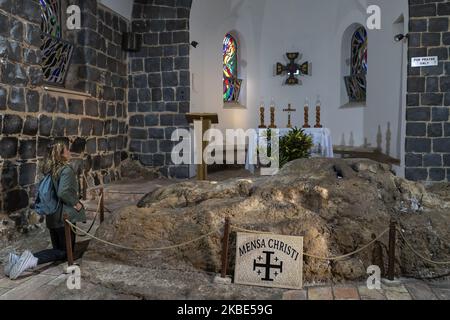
[345,27,368,102]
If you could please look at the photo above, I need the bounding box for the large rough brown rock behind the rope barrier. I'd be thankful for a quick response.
[86,159,450,282]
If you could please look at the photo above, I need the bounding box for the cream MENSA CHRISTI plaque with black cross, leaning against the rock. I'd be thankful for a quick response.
[234,233,303,289]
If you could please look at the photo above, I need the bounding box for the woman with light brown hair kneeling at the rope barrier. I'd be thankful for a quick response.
[5,143,86,280]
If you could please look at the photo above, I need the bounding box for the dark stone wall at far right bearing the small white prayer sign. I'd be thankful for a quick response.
[406,0,450,182]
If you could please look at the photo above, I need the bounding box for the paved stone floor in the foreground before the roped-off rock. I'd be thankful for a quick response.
[0,264,450,300]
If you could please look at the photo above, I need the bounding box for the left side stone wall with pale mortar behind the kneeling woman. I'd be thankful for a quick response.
[0,0,129,213]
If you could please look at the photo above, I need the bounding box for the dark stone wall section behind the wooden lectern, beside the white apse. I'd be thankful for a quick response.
[128,0,192,178]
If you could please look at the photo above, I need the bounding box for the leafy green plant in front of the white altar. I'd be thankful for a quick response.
[279,128,313,168]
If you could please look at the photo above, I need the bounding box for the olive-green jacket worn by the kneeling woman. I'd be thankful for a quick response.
[46,165,86,229]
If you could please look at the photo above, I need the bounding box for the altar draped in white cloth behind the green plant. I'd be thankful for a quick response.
[245,128,334,173]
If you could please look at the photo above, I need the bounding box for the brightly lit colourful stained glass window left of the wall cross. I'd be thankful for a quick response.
[223,34,242,102]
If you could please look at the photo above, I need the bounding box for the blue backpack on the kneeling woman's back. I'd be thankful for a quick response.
[34,170,62,216]
